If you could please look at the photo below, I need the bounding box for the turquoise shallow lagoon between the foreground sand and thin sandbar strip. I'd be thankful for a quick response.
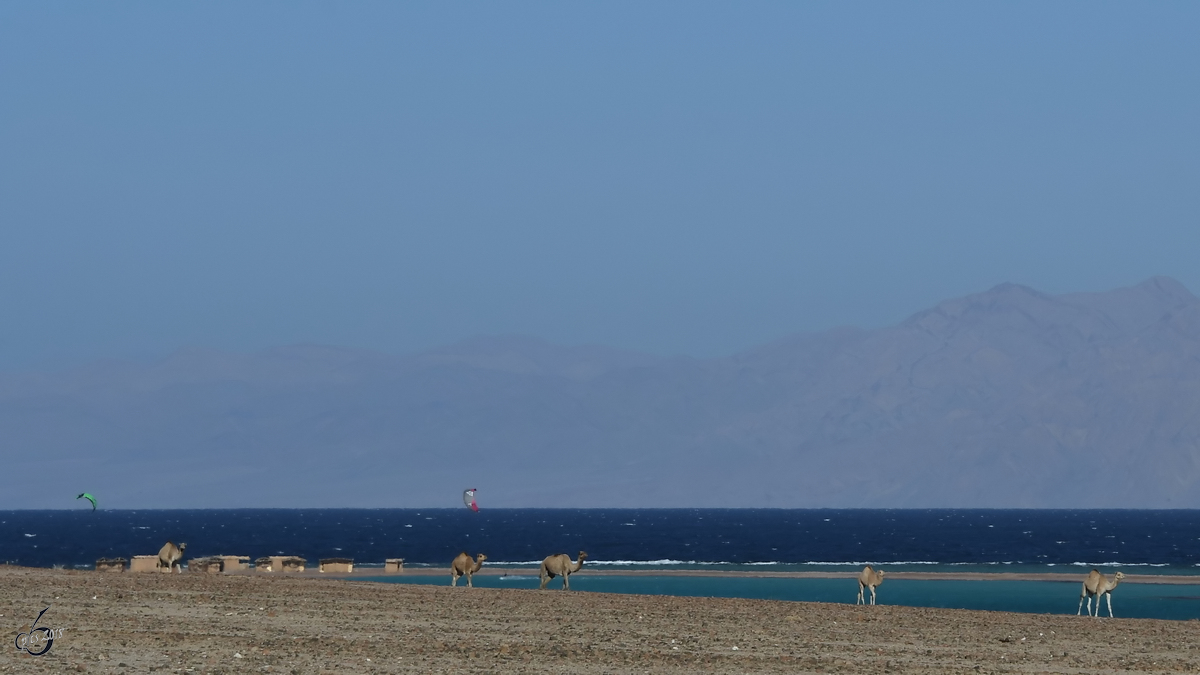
[370,572,1200,620]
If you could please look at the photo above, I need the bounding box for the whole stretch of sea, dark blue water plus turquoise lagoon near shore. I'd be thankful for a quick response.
[0,508,1200,619]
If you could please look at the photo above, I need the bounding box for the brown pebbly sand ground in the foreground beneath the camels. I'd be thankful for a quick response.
[0,567,1200,674]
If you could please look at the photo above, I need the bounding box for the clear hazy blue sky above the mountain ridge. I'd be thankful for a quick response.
[0,0,1200,369]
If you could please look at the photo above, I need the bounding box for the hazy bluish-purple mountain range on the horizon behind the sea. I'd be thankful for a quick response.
[0,277,1200,508]
